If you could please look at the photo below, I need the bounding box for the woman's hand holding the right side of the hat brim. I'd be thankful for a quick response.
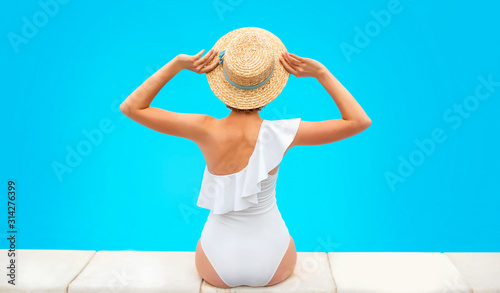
[280,52,326,78]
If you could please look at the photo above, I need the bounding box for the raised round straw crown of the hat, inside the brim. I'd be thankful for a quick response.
[223,31,275,86]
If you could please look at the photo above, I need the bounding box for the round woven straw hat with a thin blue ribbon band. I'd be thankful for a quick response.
[206,27,290,109]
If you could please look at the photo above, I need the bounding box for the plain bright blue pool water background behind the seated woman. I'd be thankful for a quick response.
[0,0,500,252]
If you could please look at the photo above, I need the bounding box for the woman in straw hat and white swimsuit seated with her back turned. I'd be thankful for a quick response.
[120,27,371,288]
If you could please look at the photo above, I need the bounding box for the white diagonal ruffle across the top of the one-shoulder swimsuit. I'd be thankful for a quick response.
[196,118,300,214]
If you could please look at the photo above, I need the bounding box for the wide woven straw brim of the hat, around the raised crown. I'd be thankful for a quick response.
[206,27,290,109]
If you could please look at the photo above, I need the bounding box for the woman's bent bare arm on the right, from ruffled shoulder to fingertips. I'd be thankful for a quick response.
[280,53,371,147]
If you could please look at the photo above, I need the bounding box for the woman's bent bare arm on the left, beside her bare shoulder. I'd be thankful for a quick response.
[120,50,218,142]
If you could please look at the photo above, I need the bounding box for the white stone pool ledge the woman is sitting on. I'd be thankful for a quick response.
[0,249,500,293]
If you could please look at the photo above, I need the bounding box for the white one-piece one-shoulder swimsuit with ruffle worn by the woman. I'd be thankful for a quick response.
[197,118,300,287]
